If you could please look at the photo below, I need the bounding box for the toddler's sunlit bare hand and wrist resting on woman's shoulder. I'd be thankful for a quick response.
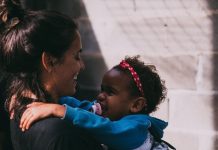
[20,102,66,131]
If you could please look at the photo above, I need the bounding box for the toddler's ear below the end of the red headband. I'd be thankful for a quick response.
[130,97,147,113]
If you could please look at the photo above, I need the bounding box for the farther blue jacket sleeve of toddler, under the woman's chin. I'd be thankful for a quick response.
[59,96,95,110]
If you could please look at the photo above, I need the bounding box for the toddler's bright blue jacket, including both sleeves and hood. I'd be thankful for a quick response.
[59,97,167,150]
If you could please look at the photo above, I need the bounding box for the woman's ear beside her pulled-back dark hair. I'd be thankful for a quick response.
[41,52,54,72]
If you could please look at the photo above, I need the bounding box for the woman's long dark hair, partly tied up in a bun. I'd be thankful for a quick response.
[0,0,78,118]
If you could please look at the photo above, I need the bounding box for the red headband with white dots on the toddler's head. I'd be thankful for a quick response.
[120,60,144,96]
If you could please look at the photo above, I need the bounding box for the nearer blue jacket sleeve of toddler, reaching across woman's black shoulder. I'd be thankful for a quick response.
[65,105,151,150]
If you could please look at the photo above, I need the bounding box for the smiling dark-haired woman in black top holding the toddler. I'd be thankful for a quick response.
[0,0,101,150]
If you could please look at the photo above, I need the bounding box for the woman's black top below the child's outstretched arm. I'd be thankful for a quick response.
[11,118,102,150]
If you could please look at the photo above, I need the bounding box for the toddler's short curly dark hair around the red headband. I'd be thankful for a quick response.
[114,56,167,114]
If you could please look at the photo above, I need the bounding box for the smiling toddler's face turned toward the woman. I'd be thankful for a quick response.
[97,69,133,120]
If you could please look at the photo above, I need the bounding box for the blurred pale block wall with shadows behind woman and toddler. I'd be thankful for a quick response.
[0,0,218,150]
